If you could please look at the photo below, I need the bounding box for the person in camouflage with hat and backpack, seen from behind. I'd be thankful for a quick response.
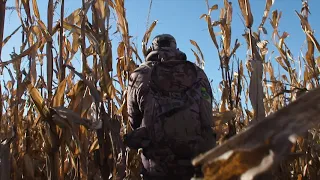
[127,35,215,179]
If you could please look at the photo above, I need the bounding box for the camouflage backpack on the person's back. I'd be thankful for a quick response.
[144,60,209,159]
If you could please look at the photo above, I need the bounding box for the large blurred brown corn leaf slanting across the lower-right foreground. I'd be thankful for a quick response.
[192,88,320,179]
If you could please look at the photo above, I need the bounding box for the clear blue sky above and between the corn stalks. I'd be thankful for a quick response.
[1,0,320,95]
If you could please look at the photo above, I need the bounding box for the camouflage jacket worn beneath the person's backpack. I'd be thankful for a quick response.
[127,49,215,177]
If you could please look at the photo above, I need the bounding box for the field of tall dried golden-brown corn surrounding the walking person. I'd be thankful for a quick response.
[0,0,320,180]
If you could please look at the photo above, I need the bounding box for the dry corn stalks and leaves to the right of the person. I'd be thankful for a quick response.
[193,0,320,180]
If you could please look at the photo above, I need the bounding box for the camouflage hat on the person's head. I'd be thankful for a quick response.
[152,34,177,50]
